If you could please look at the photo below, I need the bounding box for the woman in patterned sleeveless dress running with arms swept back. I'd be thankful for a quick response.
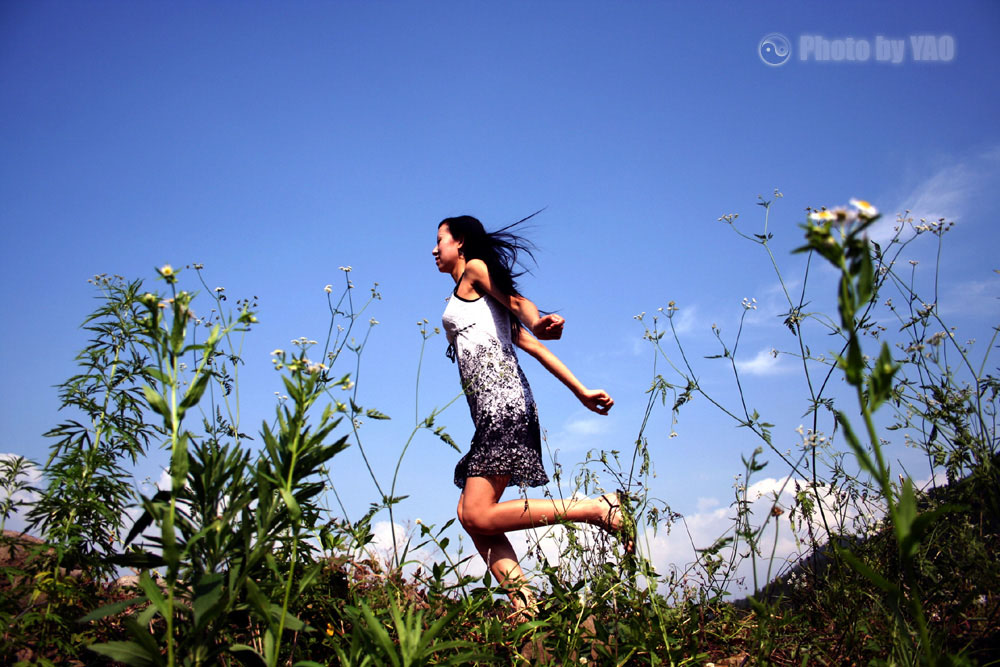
[433,216,632,609]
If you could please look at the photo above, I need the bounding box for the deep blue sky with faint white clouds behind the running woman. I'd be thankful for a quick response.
[0,1,1000,584]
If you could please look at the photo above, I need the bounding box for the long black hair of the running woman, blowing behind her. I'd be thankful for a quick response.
[438,211,541,339]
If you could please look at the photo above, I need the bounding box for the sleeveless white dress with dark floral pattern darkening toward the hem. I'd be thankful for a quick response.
[441,286,549,489]
